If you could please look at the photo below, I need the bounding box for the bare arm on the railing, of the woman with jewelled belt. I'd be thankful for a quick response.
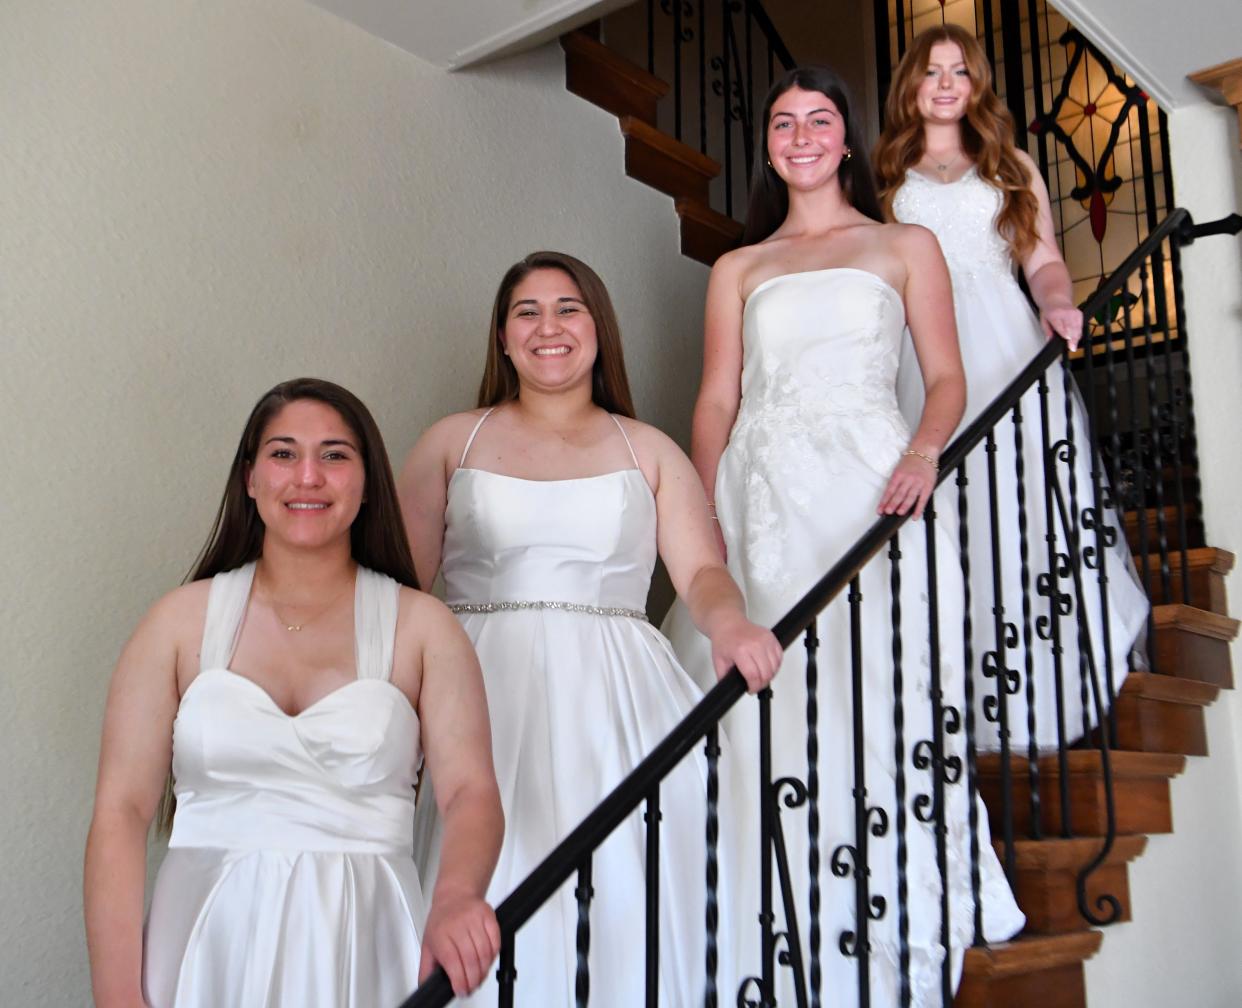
[640,427,781,691]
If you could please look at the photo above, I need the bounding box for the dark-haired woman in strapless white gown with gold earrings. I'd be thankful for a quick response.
[666,67,1022,1006]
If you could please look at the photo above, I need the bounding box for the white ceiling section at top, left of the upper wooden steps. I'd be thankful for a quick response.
[301,0,633,70]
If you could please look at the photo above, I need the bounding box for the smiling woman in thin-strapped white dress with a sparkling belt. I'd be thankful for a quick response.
[400,252,781,1006]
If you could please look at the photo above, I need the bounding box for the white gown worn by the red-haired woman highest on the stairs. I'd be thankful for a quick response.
[893,169,1149,751]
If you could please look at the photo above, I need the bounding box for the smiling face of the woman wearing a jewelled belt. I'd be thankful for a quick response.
[501,269,599,391]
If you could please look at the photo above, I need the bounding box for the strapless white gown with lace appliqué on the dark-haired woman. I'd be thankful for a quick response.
[664,268,1023,1006]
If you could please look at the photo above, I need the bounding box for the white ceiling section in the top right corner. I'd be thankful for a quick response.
[1053,0,1242,112]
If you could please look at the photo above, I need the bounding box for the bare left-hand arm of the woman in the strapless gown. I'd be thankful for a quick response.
[691,253,744,551]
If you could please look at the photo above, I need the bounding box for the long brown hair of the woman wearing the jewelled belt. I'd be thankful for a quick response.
[478,252,635,420]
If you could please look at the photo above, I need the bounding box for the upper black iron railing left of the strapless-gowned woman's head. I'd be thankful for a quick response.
[604,0,795,216]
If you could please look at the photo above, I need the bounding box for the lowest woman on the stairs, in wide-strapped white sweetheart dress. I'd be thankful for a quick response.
[86,379,502,1008]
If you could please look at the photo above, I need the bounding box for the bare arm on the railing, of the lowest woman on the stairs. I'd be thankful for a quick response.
[414,596,504,994]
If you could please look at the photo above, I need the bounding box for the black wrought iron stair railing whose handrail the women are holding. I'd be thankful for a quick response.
[402,210,1242,1008]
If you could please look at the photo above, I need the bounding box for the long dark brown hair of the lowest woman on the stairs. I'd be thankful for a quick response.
[155,377,419,835]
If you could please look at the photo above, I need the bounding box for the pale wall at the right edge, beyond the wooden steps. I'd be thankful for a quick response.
[1087,104,1242,1008]
